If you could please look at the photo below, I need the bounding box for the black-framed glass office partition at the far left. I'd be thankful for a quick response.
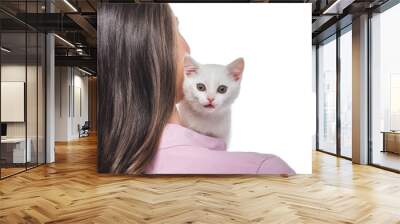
[0,1,46,178]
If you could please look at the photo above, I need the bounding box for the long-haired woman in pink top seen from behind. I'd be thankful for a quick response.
[98,4,294,175]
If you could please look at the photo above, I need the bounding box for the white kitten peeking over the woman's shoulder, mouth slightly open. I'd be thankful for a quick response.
[178,56,244,144]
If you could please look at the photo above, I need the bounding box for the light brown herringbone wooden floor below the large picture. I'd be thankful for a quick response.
[0,138,400,224]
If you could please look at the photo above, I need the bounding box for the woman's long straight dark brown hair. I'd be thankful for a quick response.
[97,3,176,174]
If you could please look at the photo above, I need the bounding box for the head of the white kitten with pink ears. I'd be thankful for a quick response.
[183,56,244,113]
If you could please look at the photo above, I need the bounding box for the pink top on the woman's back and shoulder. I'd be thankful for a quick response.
[145,123,295,175]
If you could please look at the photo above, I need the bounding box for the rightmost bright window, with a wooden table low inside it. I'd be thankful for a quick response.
[370,2,400,170]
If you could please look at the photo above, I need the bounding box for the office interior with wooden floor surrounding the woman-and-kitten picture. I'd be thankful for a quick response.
[0,0,400,224]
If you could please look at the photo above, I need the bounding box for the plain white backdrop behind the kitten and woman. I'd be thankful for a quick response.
[171,3,315,174]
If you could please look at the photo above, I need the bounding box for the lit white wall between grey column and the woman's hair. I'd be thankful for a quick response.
[55,67,88,141]
